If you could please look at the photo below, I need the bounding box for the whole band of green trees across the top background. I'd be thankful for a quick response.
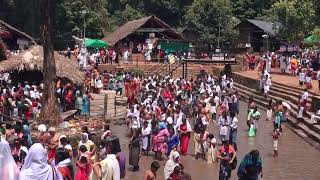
[0,0,320,49]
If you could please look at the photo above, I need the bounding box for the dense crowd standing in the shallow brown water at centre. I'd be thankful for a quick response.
[127,70,266,179]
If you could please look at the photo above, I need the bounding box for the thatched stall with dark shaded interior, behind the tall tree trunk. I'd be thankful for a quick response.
[0,45,85,84]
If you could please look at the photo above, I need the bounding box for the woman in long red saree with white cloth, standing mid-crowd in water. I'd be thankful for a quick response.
[178,117,192,156]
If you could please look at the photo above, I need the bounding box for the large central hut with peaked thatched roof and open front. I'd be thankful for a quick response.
[102,15,188,61]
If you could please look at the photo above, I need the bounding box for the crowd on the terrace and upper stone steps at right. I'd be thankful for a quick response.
[246,50,320,124]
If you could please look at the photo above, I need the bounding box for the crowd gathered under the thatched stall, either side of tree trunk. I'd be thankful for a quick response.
[0,73,96,121]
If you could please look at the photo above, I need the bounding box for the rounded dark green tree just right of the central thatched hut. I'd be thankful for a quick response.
[185,0,237,47]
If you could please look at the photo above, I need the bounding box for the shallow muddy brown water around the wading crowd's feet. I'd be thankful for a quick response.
[111,102,320,180]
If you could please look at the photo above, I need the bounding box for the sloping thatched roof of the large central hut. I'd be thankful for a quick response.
[102,16,182,45]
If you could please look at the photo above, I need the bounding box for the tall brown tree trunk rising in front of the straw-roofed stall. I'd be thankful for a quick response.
[40,0,61,126]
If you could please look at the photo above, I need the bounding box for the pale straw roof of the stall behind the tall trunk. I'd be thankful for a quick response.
[0,45,84,84]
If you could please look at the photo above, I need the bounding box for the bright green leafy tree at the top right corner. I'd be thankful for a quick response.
[270,0,315,43]
